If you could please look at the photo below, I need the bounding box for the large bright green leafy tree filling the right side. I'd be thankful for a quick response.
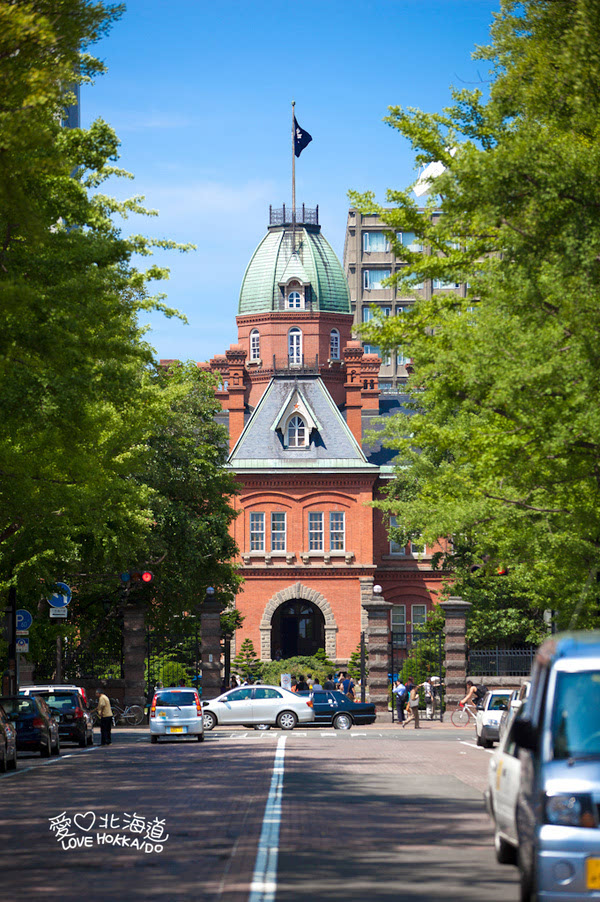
[353,0,600,626]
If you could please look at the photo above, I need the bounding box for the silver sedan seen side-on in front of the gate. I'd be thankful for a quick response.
[202,684,315,730]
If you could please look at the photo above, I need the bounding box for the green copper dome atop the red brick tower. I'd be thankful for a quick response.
[238,225,351,316]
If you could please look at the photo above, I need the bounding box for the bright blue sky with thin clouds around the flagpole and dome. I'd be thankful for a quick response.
[81,0,499,361]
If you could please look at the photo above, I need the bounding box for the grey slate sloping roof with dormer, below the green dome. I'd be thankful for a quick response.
[228,376,378,475]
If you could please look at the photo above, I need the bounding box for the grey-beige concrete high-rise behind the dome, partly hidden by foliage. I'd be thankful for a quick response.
[344,208,465,393]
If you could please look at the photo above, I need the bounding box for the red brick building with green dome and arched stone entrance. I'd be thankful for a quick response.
[185,210,442,664]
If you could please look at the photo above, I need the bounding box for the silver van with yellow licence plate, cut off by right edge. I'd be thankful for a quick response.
[507,632,600,902]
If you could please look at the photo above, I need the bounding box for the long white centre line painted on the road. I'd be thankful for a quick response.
[248,736,286,902]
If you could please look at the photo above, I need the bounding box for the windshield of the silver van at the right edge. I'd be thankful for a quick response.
[552,670,600,758]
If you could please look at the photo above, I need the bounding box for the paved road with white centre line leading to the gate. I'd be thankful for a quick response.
[0,725,518,902]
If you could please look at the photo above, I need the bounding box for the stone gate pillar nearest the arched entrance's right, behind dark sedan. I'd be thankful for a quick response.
[360,577,392,711]
